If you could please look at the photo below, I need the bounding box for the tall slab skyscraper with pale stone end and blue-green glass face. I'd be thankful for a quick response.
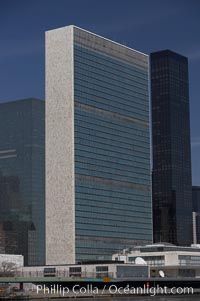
[46,26,152,264]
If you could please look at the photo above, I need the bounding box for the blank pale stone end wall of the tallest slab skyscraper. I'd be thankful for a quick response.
[45,26,75,265]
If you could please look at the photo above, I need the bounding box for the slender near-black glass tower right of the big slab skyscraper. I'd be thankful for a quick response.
[151,50,192,245]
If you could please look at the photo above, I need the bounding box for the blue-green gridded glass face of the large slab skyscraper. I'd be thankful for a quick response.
[74,28,152,261]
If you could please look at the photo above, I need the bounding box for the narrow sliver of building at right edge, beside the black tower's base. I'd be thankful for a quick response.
[192,186,200,244]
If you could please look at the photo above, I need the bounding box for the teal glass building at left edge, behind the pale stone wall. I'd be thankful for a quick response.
[0,99,45,265]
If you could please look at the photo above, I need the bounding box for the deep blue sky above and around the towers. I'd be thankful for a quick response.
[0,0,200,186]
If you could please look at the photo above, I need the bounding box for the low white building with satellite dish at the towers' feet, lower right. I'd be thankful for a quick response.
[112,243,200,277]
